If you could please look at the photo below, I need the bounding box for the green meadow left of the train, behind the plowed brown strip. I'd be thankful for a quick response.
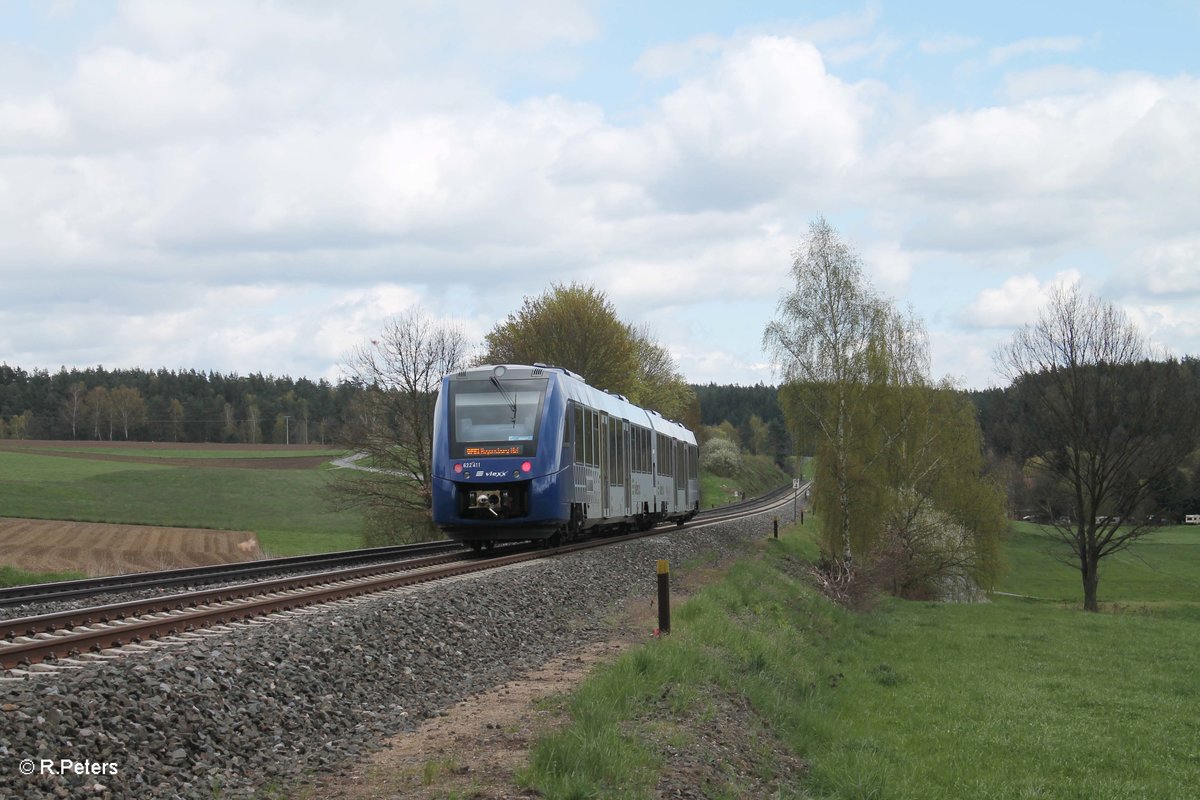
[0,441,362,566]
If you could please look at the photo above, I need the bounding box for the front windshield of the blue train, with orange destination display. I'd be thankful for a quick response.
[450,378,547,458]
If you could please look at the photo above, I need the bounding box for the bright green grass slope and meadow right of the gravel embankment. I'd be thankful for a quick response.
[522,515,1200,800]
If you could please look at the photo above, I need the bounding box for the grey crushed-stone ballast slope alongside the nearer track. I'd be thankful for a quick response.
[0,515,770,798]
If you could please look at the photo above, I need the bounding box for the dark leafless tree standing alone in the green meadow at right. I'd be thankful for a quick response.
[996,287,1196,612]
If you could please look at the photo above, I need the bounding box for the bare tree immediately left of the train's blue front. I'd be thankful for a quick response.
[334,308,468,542]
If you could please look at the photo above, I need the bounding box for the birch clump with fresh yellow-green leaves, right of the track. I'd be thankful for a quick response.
[763,219,1003,595]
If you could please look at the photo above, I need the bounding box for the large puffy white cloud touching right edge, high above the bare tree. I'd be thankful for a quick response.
[875,74,1200,249]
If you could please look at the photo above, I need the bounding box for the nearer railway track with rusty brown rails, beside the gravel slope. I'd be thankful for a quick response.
[0,488,793,670]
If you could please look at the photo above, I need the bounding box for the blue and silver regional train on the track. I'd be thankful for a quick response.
[433,365,700,549]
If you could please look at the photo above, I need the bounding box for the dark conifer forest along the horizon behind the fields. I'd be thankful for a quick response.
[0,357,1200,517]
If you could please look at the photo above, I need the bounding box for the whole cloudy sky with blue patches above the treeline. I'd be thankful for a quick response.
[0,0,1200,387]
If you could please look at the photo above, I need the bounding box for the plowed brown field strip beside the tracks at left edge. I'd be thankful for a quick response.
[0,517,263,576]
